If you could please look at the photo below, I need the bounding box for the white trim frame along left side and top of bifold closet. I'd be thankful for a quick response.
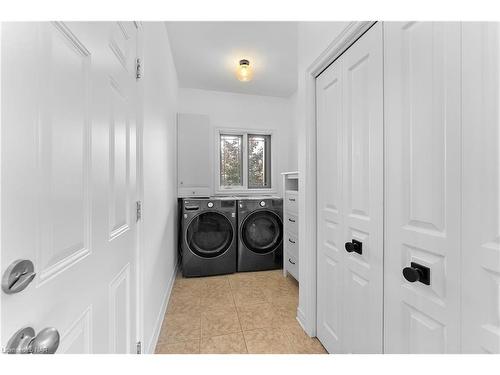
[297,21,377,337]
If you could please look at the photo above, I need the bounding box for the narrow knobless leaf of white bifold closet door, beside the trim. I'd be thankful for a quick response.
[316,52,344,353]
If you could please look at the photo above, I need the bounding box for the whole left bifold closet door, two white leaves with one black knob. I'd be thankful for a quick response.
[316,24,383,353]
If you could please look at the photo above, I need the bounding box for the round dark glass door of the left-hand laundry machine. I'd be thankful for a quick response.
[186,212,234,258]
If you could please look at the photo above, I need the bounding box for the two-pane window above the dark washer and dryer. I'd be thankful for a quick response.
[218,130,271,190]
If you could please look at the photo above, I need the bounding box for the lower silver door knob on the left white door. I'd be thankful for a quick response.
[6,327,60,354]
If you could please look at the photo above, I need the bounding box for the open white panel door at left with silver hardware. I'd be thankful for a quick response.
[1,22,137,353]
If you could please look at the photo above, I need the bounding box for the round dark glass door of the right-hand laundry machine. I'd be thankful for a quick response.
[241,210,283,254]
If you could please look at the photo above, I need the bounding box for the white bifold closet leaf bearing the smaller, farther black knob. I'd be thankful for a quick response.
[340,23,384,353]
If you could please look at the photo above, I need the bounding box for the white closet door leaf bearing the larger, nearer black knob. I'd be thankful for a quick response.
[384,22,461,353]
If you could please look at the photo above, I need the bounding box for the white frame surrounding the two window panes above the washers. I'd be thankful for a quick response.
[214,128,276,195]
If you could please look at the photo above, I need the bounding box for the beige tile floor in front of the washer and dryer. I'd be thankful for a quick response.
[156,270,326,354]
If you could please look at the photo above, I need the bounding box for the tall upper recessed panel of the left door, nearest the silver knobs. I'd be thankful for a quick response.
[35,22,92,287]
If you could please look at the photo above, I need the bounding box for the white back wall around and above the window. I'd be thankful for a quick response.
[179,88,292,193]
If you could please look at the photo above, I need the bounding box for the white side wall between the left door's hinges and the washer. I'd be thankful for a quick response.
[142,22,178,352]
